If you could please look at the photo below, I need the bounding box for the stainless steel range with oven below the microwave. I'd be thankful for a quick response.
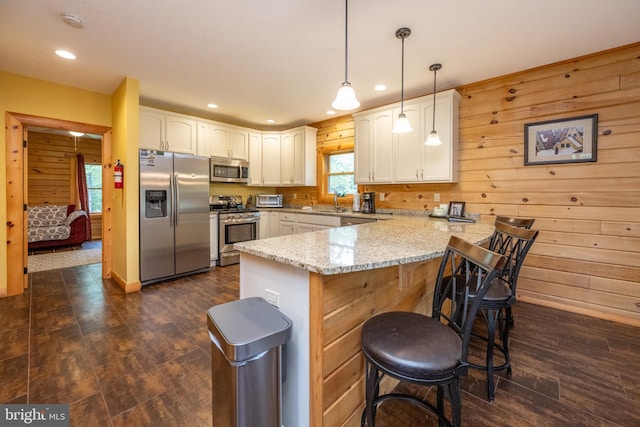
[209,195,260,267]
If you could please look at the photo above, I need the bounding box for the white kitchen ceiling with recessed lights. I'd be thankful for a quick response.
[0,0,640,130]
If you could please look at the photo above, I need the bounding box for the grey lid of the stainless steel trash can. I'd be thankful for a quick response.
[207,297,293,362]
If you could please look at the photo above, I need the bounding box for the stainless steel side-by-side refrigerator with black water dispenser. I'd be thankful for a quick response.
[140,150,210,285]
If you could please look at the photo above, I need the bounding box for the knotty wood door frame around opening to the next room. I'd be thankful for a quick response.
[5,113,112,296]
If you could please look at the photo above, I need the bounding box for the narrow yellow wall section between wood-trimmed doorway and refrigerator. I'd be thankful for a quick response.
[111,78,140,287]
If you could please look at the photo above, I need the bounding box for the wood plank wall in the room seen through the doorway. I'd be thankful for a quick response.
[27,131,102,240]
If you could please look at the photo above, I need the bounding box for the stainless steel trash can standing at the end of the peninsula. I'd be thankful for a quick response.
[207,297,293,427]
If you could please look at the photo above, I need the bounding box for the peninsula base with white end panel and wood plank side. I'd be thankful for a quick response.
[240,253,440,427]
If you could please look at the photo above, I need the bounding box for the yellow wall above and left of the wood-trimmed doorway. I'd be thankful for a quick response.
[0,71,111,294]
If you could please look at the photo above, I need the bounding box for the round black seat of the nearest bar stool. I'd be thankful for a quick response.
[362,311,462,382]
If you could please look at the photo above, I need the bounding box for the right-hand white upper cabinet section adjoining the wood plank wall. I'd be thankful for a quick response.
[394,90,460,183]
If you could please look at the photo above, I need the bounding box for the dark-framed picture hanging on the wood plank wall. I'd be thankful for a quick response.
[524,114,598,166]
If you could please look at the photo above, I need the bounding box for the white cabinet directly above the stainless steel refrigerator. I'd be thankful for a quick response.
[139,107,196,154]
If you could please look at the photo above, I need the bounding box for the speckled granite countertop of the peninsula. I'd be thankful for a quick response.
[234,214,494,275]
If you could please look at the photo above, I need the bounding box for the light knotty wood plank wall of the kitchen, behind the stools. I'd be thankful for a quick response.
[280,43,640,325]
